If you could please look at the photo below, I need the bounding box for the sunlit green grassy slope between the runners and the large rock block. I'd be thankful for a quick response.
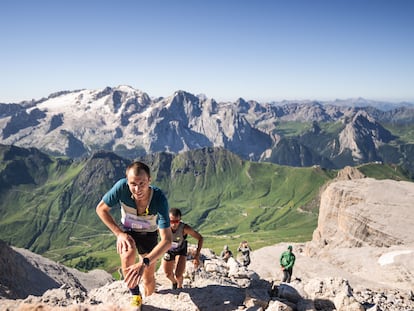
[162,151,336,251]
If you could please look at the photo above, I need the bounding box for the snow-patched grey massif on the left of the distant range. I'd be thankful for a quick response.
[0,86,271,161]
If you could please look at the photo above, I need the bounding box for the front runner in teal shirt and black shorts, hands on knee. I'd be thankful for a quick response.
[96,161,172,310]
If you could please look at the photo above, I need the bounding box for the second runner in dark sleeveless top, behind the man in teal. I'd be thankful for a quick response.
[162,208,203,289]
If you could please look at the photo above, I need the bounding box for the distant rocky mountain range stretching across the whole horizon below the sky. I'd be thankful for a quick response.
[0,86,414,171]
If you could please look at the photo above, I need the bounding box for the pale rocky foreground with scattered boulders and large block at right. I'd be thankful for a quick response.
[0,168,414,311]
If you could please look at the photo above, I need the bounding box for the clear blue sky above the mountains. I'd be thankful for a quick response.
[0,0,414,103]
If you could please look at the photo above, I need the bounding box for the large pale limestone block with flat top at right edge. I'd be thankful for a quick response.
[313,178,414,248]
